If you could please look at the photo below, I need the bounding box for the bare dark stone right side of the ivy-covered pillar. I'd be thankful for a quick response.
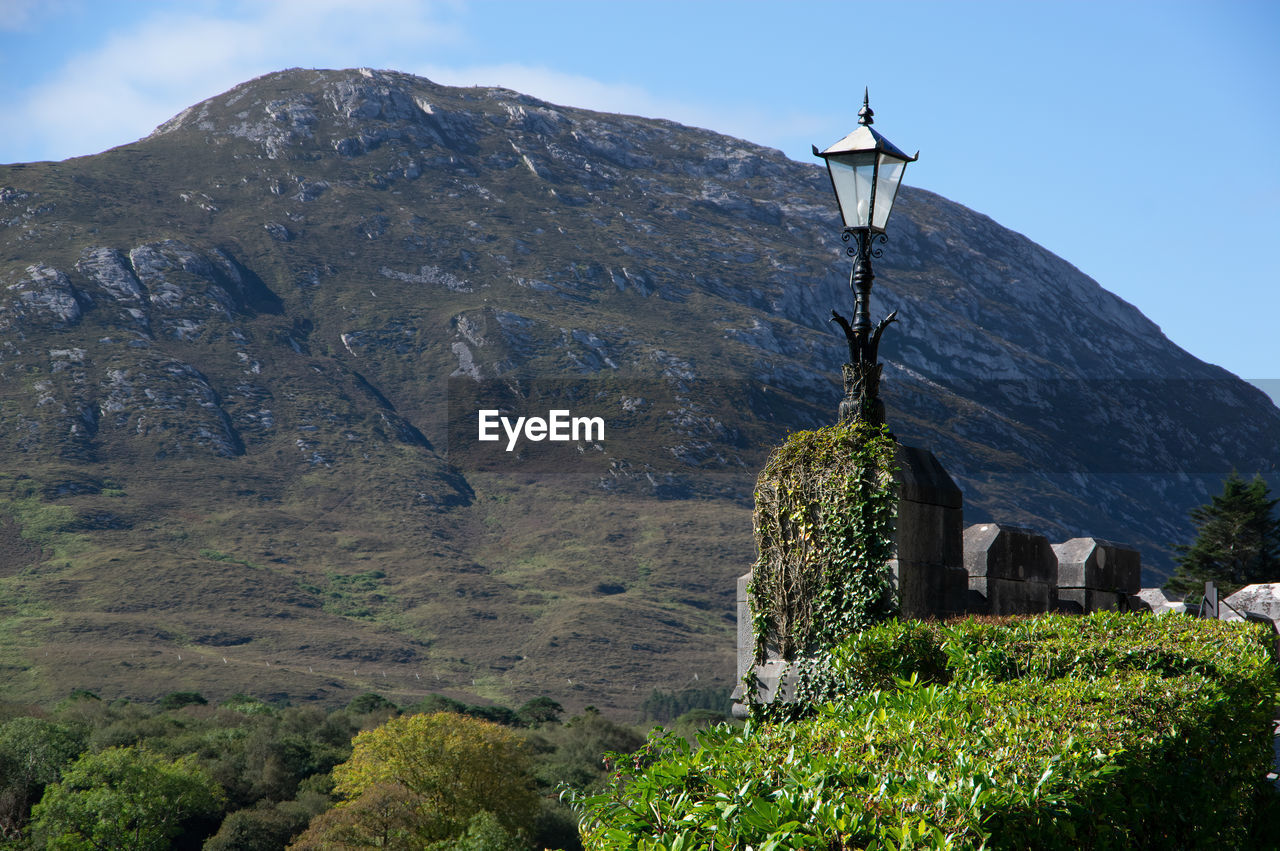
[890,444,968,618]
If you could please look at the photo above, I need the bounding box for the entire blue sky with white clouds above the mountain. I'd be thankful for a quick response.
[0,0,1280,395]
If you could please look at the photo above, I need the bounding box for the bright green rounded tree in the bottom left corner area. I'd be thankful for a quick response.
[31,747,224,851]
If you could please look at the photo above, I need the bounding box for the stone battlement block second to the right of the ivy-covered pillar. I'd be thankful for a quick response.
[1053,537,1149,614]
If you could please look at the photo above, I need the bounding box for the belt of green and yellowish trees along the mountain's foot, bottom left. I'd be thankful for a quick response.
[0,691,724,851]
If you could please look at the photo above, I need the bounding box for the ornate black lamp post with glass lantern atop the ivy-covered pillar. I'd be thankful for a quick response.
[813,91,920,425]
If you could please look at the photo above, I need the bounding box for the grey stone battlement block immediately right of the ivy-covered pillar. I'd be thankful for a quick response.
[964,523,1059,614]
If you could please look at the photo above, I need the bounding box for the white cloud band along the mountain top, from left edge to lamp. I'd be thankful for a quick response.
[0,0,829,161]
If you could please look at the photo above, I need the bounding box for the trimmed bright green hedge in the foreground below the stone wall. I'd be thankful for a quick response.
[580,613,1277,851]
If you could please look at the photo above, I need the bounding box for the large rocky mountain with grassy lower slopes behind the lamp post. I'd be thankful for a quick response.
[0,69,1280,708]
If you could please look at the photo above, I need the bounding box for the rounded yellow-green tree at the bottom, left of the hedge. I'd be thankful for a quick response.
[292,713,539,848]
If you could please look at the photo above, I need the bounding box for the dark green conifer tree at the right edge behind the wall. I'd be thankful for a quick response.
[1165,471,1280,594]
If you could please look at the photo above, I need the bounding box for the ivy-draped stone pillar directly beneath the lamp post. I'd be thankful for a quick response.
[736,420,968,714]
